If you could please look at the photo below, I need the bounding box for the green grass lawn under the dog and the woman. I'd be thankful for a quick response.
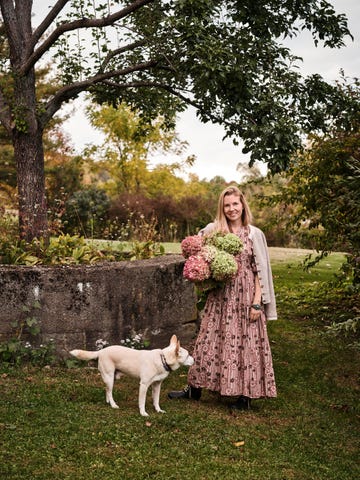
[0,251,360,480]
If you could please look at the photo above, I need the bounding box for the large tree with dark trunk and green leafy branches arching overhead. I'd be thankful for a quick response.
[0,0,350,239]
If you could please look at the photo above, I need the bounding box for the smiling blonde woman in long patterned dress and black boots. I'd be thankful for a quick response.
[168,186,277,409]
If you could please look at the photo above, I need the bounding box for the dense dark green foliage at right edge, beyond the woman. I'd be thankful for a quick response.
[281,80,360,283]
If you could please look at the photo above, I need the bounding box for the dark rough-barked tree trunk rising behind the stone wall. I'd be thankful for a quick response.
[0,0,49,242]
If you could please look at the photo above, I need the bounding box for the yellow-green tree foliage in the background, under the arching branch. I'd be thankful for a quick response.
[87,103,193,196]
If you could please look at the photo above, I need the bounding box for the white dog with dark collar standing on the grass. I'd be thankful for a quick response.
[70,335,194,417]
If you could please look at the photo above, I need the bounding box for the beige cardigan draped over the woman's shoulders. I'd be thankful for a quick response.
[199,223,277,320]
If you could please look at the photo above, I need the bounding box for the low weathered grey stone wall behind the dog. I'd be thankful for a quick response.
[0,255,197,356]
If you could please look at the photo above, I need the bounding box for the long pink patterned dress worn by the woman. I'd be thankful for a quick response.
[188,227,276,398]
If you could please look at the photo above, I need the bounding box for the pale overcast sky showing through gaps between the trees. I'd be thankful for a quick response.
[54,0,360,182]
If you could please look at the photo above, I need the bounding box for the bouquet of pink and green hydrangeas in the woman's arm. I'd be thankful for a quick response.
[181,232,243,306]
